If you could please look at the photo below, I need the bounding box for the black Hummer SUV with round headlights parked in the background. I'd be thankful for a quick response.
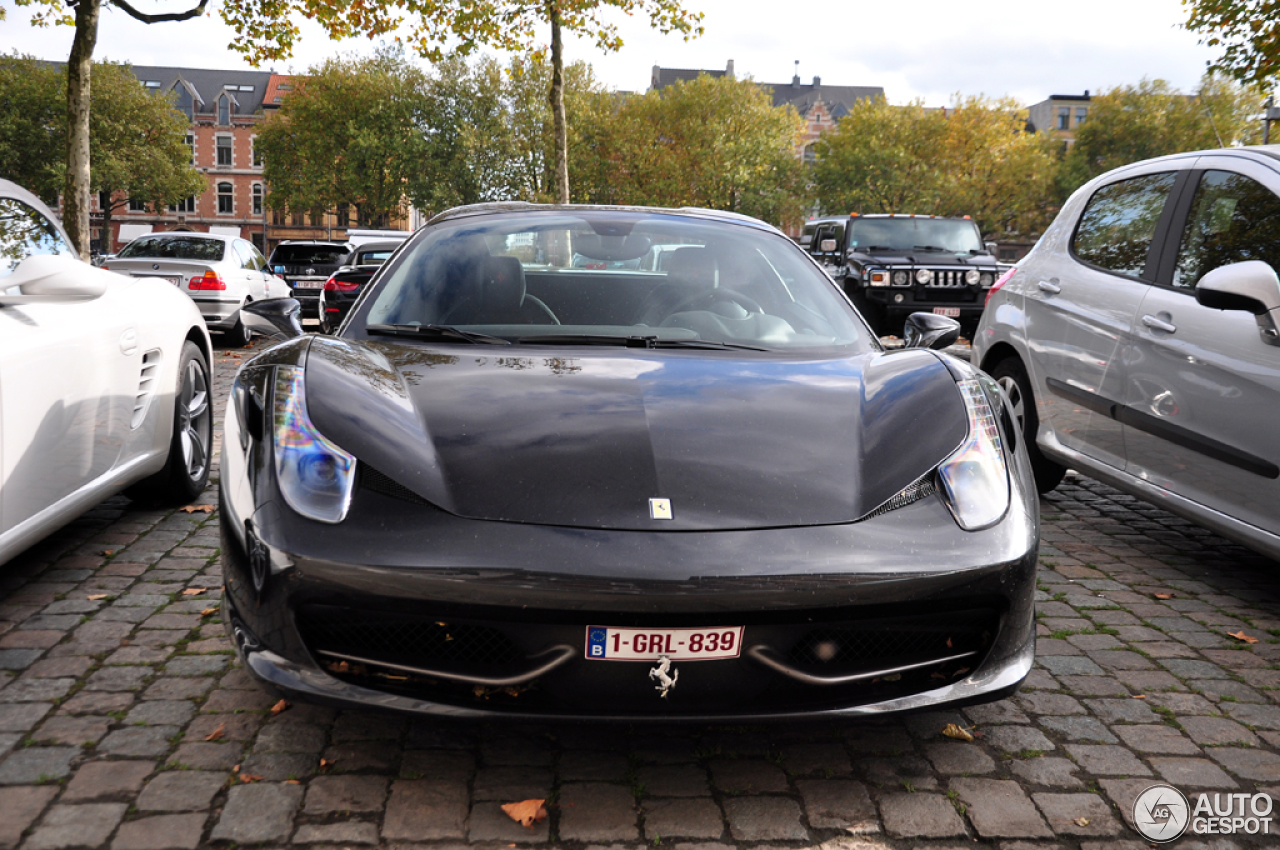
[800,214,1000,335]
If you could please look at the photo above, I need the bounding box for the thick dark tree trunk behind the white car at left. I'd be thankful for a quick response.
[63,0,101,260]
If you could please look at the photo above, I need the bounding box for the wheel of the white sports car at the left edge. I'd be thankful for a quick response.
[125,341,214,504]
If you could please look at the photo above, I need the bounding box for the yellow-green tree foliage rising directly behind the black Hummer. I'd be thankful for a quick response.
[812,97,1057,233]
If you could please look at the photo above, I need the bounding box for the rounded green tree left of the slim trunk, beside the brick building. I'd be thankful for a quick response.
[256,49,426,223]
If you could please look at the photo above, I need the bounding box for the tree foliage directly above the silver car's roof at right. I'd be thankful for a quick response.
[1060,74,1261,196]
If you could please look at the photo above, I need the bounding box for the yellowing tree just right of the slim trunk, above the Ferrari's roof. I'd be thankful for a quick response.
[570,74,804,223]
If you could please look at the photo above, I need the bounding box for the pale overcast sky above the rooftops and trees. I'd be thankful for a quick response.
[0,0,1213,105]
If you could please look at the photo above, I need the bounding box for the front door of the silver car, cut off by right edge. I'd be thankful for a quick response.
[1121,157,1280,533]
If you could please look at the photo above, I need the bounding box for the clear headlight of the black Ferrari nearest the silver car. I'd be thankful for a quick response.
[938,379,1009,531]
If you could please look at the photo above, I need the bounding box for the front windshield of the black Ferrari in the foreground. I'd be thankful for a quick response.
[347,210,873,349]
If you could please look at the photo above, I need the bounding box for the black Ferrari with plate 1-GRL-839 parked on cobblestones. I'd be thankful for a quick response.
[219,204,1038,718]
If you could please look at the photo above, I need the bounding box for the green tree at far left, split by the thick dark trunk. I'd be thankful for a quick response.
[0,56,205,245]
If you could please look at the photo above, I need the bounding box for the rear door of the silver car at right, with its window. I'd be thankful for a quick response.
[1023,164,1178,469]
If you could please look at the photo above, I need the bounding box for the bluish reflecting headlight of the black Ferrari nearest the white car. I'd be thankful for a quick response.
[271,366,356,524]
